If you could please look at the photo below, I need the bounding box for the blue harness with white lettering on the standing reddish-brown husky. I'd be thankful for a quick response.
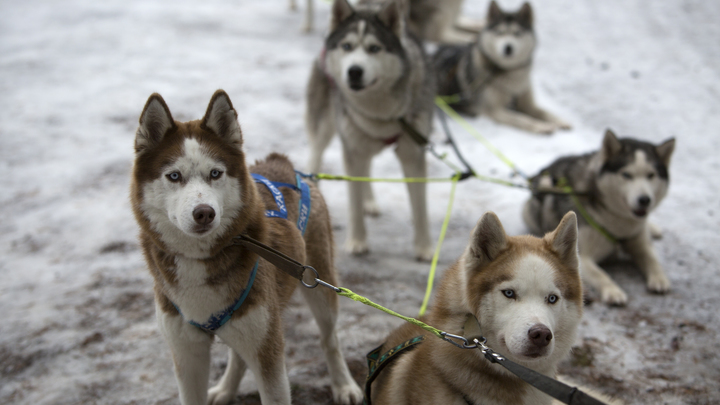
[173,173,310,332]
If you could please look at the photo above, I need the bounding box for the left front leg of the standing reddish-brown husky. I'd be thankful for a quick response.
[156,307,213,405]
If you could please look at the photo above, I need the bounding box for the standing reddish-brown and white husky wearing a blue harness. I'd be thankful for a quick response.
[131,90,362,405]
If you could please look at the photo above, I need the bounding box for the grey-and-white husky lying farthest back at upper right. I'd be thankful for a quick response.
[433,1,570,134]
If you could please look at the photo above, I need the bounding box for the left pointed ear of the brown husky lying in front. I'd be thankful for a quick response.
[465,211,508,268]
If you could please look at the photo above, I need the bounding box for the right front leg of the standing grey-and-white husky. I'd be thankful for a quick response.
[395,136,433,261]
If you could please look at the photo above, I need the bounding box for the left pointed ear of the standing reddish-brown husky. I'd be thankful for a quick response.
[135,93,175,153]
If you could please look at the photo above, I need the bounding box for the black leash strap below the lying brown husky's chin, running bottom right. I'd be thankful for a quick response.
[474,339,606,405]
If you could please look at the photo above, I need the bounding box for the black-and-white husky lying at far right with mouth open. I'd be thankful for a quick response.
[523,130,675,305]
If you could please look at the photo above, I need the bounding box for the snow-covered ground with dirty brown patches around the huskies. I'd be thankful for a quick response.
[0,0,720,404]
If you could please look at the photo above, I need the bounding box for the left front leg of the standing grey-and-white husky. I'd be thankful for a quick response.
[343,145,372,255]
